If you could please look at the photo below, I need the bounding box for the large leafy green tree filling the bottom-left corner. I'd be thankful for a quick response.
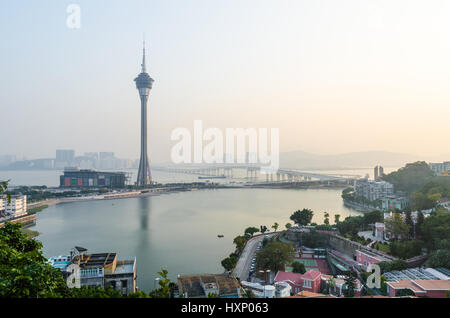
[0,222,69,298]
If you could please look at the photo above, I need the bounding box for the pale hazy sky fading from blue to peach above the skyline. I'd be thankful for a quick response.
[0,0,450,162]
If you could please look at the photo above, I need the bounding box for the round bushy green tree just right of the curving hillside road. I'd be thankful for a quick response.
[256,241,294,272]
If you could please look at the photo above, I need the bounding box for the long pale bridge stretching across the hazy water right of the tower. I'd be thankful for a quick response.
[152,164,361,182]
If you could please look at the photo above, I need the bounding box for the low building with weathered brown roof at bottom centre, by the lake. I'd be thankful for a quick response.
[178,274,241,298]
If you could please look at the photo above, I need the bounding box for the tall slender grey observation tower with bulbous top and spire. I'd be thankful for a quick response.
[134,43,154,186]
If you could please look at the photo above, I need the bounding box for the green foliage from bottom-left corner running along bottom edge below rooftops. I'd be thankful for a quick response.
[0,222,175,298]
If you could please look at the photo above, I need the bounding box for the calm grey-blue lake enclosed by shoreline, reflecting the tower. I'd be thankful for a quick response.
[29,189,359,291]
